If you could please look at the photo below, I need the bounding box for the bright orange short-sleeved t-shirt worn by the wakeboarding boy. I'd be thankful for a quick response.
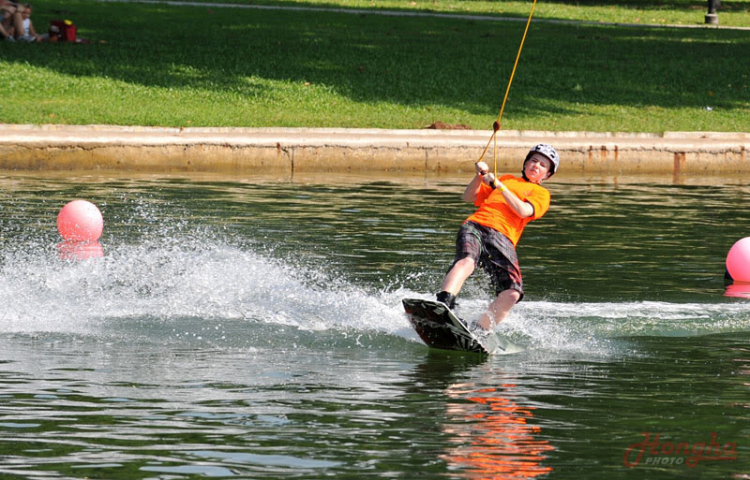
[466,175,550,245]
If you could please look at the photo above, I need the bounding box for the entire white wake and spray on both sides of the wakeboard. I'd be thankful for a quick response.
[0,237,750,351]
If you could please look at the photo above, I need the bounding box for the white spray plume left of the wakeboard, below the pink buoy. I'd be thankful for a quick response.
[0,240,407,342]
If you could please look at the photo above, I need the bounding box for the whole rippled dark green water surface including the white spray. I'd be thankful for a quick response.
[0,173,750,478]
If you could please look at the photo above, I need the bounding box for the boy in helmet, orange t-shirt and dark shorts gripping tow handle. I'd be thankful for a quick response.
[437,143,560,335]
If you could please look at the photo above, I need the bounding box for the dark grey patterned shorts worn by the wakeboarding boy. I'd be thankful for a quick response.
[451,222,523,301]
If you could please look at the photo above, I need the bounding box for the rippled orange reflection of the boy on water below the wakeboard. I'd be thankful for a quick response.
[411,350,555,480]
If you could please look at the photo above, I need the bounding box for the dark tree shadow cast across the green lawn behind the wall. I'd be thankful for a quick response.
[0,1,750,126]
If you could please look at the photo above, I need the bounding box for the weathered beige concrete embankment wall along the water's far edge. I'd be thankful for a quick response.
[0,124,750,175]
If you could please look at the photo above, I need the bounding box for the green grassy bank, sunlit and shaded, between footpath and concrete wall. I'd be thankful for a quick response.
[0,0,750,132]
